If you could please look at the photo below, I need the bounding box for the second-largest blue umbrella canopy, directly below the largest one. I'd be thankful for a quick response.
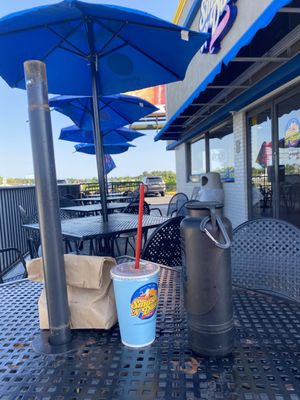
[49,94,158,134]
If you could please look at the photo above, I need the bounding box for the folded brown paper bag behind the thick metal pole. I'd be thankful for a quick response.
[27,254,117,329]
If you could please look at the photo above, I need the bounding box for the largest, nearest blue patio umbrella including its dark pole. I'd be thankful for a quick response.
[0,0,209,221]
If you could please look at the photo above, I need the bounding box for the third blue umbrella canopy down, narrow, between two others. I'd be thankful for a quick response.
[59,125,145,144]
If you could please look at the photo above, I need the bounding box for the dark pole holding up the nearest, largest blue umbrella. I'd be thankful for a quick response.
[91,62,108,222]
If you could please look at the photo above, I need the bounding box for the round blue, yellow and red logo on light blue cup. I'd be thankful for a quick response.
[130,283,158,319]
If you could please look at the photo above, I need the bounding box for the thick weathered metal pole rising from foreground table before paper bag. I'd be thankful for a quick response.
[24,61,71,346]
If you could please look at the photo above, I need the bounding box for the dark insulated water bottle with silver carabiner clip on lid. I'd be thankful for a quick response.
[181,202,234,357]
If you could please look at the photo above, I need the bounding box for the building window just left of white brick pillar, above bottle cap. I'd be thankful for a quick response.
[209,121,234,182]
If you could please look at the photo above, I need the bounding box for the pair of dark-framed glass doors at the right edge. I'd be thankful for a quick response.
[247,87,300,227]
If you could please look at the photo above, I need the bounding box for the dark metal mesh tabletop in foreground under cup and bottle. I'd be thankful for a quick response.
[0,270,300,400]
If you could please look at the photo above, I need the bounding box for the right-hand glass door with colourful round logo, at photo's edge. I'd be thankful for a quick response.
[275,93,300,227]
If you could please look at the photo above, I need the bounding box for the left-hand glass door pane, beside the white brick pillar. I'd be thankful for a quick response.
[248,107,275,218]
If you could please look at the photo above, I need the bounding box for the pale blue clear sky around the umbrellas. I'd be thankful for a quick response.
[0,0,178,179]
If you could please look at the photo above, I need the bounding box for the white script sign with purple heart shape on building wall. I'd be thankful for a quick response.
[199,0,237,54]
